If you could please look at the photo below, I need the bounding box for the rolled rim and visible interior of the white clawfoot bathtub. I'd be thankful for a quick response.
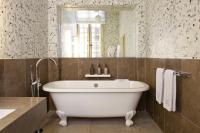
[43,79,148,92]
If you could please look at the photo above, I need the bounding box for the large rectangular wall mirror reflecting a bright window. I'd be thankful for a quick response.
[58,6,137,58]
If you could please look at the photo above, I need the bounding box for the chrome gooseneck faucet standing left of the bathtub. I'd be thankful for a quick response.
[32,58,57,97]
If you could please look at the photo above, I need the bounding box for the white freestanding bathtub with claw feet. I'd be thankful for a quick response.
[43,79,149,126]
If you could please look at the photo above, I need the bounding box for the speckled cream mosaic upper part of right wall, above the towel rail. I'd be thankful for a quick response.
[146,0,200,58]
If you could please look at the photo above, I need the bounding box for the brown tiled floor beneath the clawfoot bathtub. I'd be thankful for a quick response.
[43,112,162,133]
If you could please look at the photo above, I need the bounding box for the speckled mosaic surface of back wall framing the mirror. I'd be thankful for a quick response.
[48,0,146,57]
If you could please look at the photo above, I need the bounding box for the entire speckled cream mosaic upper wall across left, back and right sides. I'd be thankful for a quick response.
[0,0,200,59]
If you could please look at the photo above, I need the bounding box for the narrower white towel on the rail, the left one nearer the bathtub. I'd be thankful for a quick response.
[156,68,165,104]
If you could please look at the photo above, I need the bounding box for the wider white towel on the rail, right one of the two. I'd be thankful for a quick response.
[163,70,176,112]
